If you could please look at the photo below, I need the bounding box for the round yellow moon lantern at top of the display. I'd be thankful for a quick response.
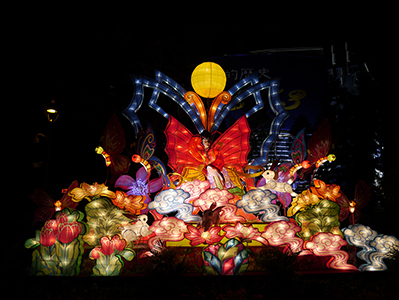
[191,62,226,98]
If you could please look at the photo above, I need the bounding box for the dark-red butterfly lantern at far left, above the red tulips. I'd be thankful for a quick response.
[30,180,79,224]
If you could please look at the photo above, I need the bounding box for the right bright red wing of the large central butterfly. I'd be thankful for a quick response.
[211,116,251,168]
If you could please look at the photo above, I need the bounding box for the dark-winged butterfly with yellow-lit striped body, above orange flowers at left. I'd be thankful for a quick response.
[95,114,130,183]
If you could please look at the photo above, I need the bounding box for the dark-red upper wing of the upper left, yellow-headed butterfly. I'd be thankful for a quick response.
[103,114,126,156]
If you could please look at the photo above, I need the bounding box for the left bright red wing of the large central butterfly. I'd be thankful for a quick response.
[165,116,198,173]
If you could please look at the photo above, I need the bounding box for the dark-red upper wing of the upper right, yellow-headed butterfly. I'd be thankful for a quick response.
[308,119,331,165]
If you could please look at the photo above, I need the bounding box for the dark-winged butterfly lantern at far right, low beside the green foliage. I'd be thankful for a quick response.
[337,180,371,225]
